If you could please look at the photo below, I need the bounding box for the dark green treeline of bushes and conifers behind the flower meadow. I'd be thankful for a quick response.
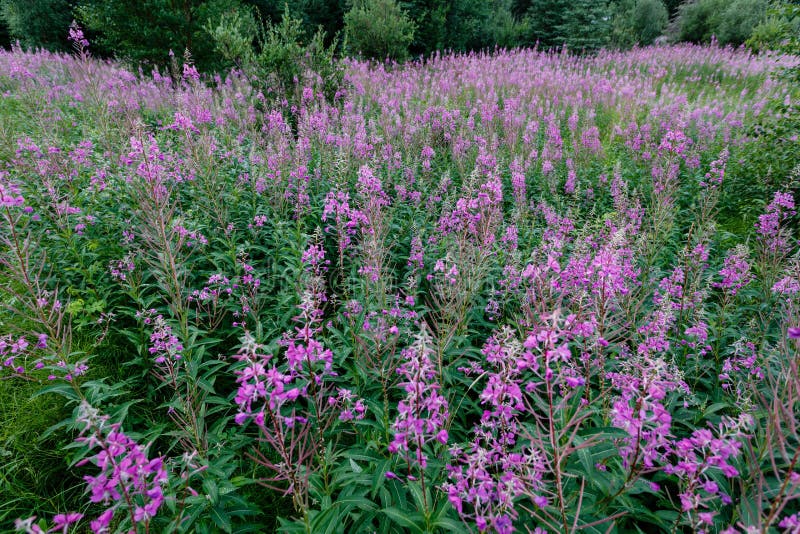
[0,0,800,70]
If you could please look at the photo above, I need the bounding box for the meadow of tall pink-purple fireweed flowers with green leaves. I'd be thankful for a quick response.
[0,36,800,534]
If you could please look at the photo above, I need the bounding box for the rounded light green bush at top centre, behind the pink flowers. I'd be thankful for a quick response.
[344,0,415,61]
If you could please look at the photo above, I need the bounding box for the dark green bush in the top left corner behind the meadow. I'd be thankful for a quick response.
[0,0,73,50]
